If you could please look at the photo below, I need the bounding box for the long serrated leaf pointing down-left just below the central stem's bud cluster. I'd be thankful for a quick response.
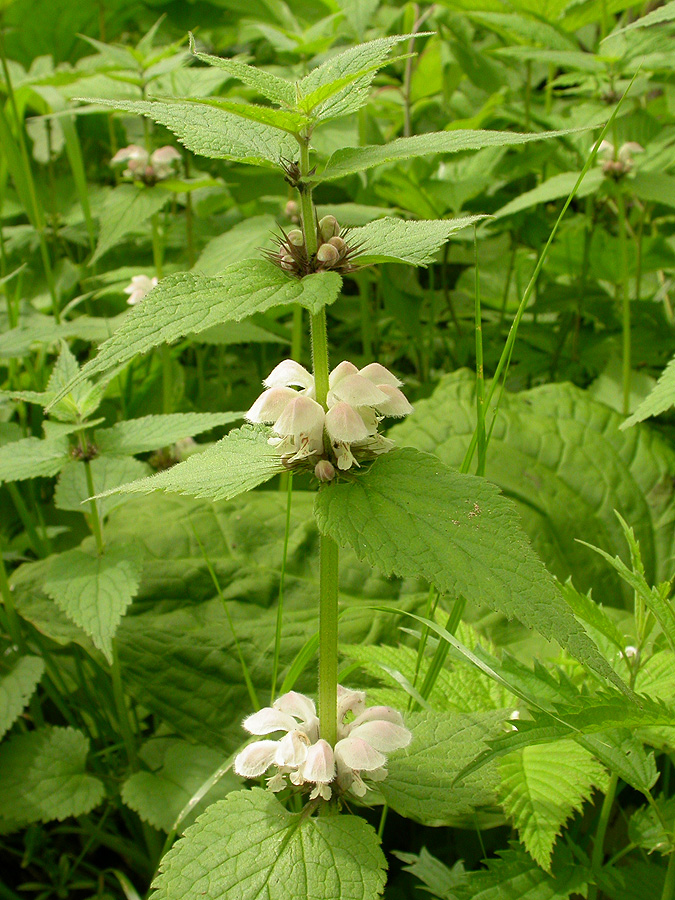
[47,260,342,404]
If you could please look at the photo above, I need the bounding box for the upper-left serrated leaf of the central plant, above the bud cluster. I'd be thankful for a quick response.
[84,100,298,169]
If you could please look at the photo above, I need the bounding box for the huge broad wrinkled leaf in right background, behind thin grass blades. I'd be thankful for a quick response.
[389,372,675,606]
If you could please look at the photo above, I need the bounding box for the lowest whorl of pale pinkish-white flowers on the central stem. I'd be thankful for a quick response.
[234,685,412,800]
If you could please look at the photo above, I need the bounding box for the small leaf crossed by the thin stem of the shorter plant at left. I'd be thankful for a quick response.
[54,456,150,519]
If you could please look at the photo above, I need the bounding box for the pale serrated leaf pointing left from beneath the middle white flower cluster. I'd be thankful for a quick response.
[96,425,285,500]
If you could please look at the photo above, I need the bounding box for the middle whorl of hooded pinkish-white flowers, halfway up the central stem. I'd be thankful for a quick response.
[246,359,412,481]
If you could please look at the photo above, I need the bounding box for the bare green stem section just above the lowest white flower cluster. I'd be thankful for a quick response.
[319,535,338,747]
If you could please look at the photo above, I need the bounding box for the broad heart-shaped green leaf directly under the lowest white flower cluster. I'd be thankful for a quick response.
[154,788,386,900]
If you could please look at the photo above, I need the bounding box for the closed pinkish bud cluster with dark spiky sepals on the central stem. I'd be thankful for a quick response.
[266,216,360,278]
